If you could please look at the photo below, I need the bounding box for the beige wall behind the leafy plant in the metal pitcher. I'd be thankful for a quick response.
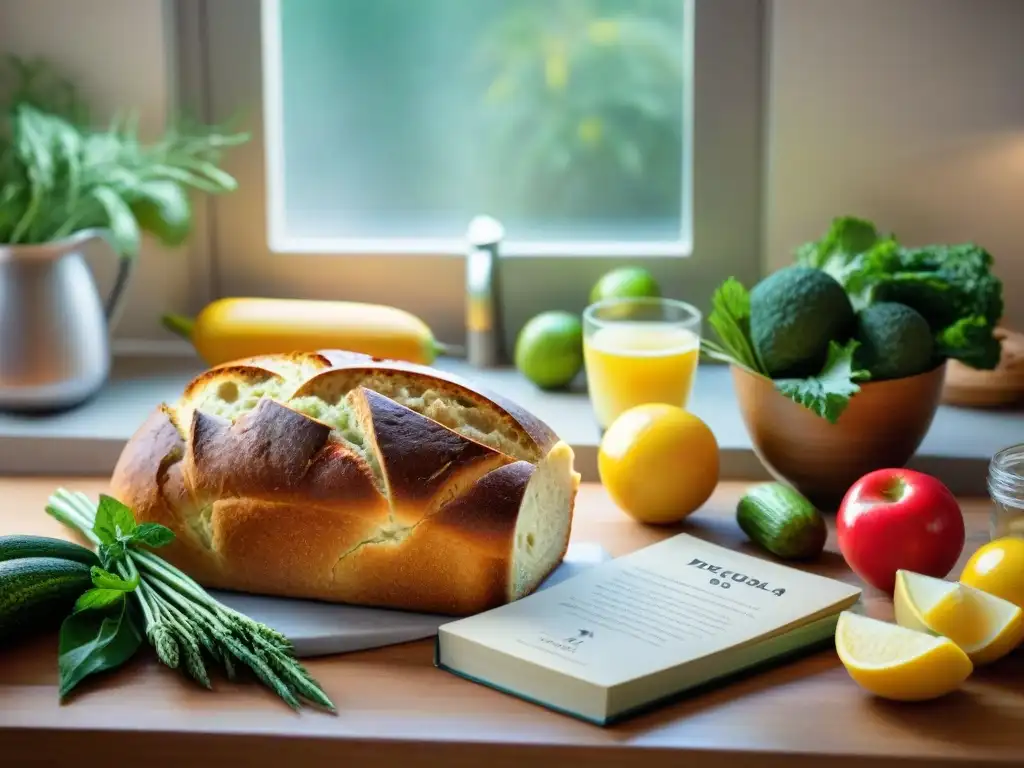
[0,0,198,348]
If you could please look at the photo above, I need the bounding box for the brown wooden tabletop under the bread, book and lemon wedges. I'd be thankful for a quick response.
[0,478,1024,768]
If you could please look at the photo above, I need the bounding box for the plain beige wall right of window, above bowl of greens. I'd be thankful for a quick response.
[765,0,1024,327]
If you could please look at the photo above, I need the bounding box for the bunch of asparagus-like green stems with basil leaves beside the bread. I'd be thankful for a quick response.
[46,488,334,712]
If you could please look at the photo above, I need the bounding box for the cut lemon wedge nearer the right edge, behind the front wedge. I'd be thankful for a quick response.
[893,570,1024,667]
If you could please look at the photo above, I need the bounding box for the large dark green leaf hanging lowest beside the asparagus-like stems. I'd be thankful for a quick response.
[57,597,142,699]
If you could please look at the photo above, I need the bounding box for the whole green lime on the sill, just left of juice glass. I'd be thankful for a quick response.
[515,310,583,389]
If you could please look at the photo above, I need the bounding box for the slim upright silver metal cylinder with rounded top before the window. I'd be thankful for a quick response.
[466,216,505,368]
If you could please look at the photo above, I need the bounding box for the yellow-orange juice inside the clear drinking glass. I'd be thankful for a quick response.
[584,321,700,429]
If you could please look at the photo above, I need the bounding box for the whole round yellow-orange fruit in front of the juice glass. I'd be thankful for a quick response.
[597,403,719,523]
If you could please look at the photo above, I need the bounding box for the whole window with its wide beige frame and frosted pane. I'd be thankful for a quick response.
[195,0,762,343]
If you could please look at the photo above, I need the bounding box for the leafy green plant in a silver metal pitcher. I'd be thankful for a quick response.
[0,57,248,411]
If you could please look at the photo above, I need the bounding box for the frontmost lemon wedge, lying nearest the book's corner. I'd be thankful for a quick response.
[836,610,974,701]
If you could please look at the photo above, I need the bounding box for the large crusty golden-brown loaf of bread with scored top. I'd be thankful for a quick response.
[112,350,580,615]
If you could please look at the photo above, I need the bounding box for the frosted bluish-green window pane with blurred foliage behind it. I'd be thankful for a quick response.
[269,0,691,243]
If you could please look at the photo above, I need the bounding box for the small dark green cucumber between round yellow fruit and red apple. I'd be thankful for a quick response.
[736,482,828,560]
